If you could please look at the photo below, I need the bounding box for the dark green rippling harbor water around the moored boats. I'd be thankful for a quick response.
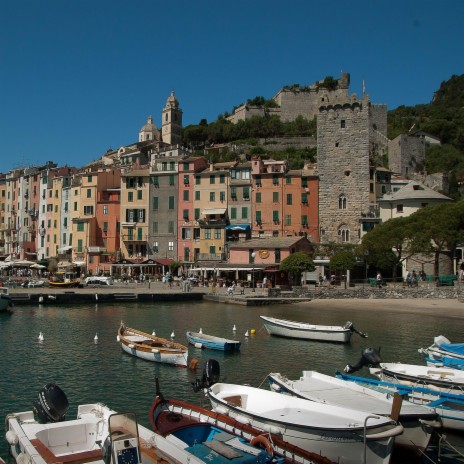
[0,300,464,462]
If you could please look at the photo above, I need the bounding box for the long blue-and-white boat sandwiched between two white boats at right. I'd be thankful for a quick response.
[336,372,464,431]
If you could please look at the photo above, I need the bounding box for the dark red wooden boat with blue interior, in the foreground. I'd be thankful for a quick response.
[149,396,332,464]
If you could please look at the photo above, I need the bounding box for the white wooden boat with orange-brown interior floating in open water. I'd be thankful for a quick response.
[117,321,188,367]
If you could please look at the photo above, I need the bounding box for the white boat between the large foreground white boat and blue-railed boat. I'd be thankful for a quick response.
[269,371,442,452]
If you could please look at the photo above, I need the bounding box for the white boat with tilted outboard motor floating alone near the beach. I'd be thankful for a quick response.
[260,316,367,343]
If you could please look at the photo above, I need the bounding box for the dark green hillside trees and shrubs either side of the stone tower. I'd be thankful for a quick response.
[183,75,464,178]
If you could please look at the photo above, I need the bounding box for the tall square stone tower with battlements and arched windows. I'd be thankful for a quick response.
[317,94,375,244]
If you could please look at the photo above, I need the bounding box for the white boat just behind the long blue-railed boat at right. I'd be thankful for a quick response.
[369,363,464,393]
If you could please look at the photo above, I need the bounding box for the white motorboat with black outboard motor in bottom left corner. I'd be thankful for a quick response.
[5,384,224,464]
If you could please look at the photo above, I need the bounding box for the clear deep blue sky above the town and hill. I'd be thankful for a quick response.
[0,0,464,172]
